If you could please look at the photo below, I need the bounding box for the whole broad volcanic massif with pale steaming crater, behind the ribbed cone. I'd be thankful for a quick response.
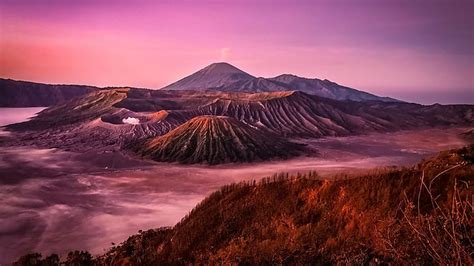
[6,89,474,154]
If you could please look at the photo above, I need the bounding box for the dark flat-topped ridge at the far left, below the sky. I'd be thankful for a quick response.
[0,79,98,107]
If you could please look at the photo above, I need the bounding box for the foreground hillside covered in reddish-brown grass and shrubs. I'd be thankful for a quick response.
[18,146,474,265]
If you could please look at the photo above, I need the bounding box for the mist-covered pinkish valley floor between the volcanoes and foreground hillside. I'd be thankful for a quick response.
[0,122,468,264]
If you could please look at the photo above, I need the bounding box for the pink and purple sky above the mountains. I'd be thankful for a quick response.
[0,0,474,103]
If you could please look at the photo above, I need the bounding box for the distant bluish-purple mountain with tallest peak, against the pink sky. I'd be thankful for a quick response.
[162,62,400,102]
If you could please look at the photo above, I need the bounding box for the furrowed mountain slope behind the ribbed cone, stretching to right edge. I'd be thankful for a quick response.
[161,92,474,138]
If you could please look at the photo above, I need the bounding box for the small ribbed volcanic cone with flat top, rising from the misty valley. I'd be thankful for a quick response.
[133,116,303,164]
